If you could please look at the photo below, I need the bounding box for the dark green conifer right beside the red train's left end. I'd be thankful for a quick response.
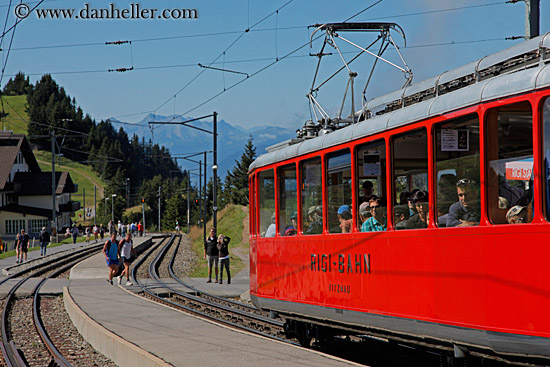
[225,136,256,205]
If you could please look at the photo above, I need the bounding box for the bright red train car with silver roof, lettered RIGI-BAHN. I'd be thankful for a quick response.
[249,34,550,364]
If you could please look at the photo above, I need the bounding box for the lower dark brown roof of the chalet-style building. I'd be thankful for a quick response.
[13,172,77,196]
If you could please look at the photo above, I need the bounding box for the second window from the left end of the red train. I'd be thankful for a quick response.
[278,165,298,237]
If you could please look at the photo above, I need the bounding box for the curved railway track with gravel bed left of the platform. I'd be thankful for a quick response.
[0,244,103,367]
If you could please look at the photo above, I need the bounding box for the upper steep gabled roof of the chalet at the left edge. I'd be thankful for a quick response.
[0,132,40,190]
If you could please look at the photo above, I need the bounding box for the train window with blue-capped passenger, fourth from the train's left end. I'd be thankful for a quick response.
[327,149,353,233]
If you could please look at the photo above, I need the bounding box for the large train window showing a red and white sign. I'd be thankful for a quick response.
[484,101,535,225]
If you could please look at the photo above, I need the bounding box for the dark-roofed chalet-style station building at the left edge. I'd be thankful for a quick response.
[0,131,80,242]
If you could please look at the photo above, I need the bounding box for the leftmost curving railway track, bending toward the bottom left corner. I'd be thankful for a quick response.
[0,244,103,367]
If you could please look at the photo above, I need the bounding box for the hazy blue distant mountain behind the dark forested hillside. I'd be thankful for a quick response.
[111,114,296,179]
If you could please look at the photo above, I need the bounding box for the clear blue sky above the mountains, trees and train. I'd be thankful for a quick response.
[0,0,550,128]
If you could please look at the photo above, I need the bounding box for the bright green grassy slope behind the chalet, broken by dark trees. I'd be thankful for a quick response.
[1,96,105,221]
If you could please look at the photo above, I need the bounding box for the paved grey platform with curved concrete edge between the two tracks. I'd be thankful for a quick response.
[63,237,362,367]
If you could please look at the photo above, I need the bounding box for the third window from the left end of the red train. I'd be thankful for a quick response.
[298,157,324,236]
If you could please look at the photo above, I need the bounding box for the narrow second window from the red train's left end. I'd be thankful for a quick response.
[277,163,298,236]
